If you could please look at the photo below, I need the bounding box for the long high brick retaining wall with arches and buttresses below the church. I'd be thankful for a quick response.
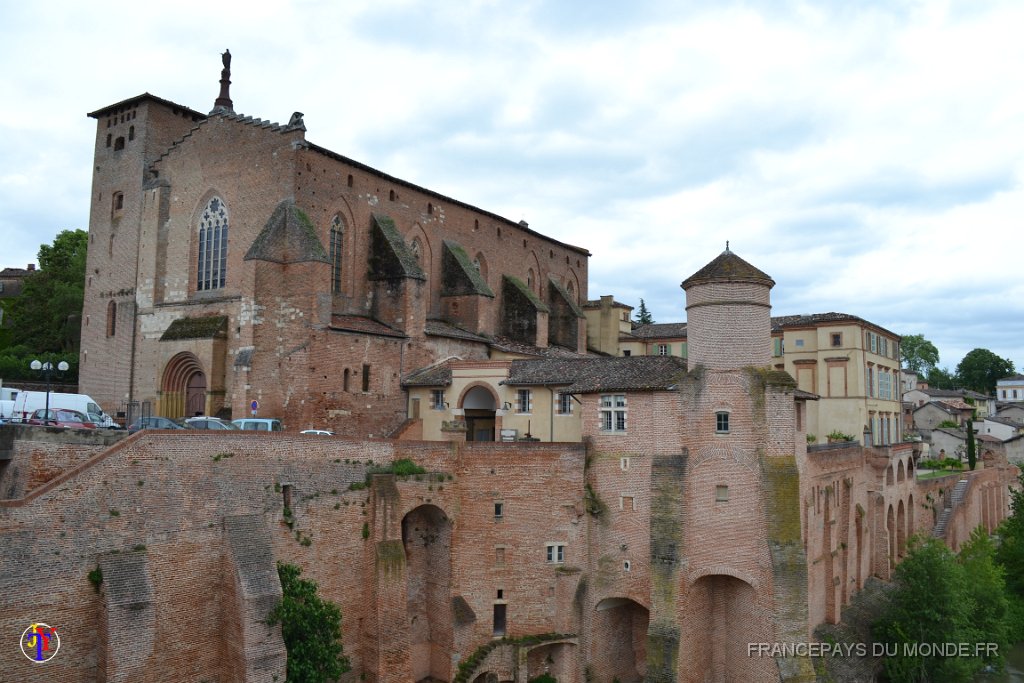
[0,417,1017,683]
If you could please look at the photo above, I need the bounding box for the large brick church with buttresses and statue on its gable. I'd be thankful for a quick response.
[80,52,590,436]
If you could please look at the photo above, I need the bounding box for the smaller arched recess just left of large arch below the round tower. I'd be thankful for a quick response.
[590,598,650,683]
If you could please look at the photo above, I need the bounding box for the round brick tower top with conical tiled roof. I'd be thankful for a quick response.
[681,242,775,370]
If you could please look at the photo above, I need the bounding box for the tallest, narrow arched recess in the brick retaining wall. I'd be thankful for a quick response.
[401,505,453,681]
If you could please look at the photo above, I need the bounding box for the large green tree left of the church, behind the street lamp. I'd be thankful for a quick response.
[7,230,89,355]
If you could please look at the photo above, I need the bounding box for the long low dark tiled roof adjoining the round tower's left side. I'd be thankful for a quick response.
[502,355,686,393]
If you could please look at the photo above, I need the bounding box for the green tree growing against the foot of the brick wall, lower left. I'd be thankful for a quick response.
[267,562,349,683]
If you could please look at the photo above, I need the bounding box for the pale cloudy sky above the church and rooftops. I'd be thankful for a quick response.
[0,0,1024,370]
